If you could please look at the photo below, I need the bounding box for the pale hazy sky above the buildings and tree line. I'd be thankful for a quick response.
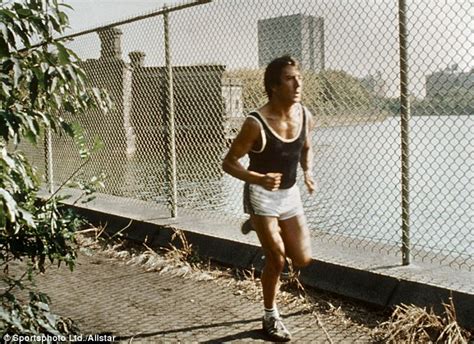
[63,0,474,96]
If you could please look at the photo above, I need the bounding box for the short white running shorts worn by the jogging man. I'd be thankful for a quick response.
[244,183,303,220]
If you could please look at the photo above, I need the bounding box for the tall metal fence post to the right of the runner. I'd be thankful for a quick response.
[398,0,410,265]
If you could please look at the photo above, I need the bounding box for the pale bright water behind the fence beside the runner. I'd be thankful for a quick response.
[223,116,474,257]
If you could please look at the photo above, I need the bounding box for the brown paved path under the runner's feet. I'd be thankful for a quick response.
[37,251,378,343]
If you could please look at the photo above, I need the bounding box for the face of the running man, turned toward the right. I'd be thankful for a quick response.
[272,66,303,103]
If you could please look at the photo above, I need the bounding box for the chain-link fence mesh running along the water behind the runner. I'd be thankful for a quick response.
[19,0,474,271]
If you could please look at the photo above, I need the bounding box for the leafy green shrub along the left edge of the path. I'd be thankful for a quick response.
[0,0,110,334]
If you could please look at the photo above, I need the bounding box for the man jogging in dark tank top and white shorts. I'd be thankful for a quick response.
[222,56,315,341]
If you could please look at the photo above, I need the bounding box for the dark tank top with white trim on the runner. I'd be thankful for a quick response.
[248,106,306,189]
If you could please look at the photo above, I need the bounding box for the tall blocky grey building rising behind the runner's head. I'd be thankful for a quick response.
[258,14,324,72]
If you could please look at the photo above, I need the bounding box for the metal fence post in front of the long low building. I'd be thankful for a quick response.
[163,9,178,217]
